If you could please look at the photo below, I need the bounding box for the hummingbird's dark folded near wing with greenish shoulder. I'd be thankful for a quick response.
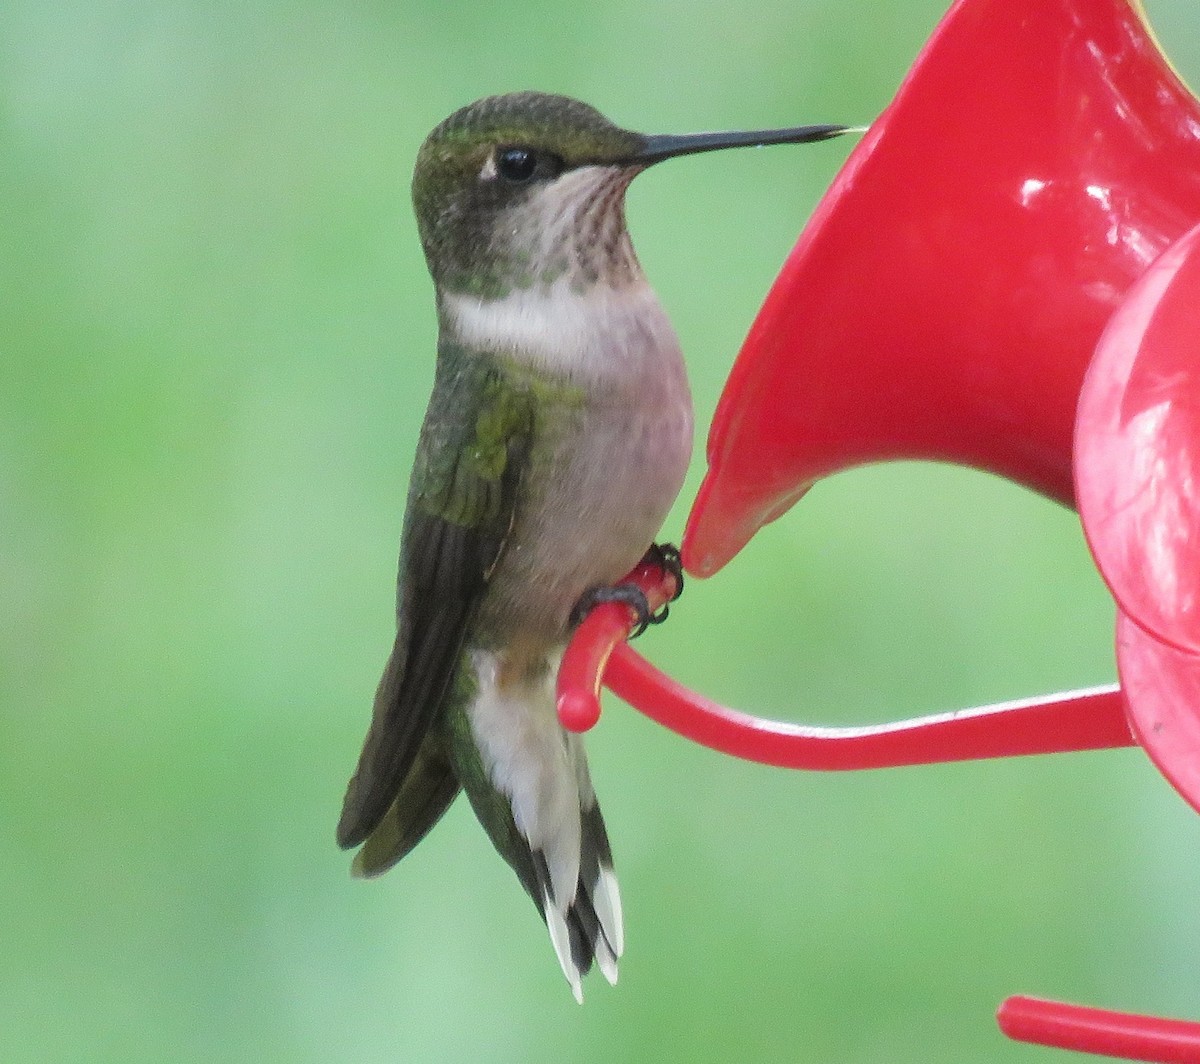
[337,345,533,849]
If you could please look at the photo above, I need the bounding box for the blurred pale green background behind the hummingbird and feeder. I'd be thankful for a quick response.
[7,0,1200,1064]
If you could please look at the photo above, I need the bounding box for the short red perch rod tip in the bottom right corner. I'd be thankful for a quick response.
[996,996,1200,1064]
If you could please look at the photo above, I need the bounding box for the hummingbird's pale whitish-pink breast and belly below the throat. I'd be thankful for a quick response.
[448,283,692,643]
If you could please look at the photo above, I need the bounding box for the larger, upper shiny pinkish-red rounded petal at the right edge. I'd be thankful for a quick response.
[1075,224,1200,653]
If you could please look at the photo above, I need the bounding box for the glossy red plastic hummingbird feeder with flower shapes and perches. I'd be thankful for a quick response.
[559,0,1200,1062]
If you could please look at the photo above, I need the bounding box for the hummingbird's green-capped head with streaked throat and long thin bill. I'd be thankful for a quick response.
[413,92,846,299]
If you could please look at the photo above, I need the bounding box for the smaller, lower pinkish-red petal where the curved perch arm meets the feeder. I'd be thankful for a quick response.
[1117,613,1200,811]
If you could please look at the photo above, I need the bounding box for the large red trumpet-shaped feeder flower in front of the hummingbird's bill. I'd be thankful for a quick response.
[683,0,1200,576]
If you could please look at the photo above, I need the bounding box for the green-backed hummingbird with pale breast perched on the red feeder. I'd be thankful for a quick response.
[337,92,847,1002]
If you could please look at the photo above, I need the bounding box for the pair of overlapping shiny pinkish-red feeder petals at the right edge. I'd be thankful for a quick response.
[1075,226,1200,810]
